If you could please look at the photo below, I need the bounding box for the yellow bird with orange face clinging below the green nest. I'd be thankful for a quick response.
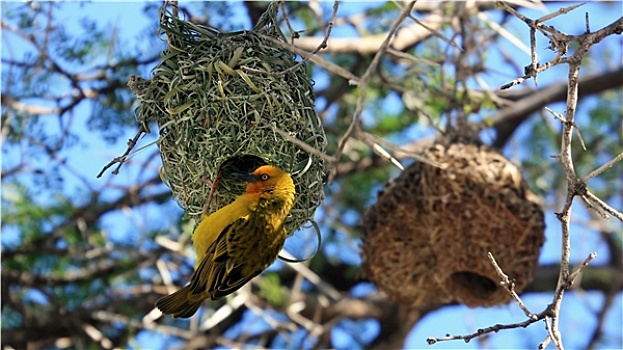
[156,165,295,318]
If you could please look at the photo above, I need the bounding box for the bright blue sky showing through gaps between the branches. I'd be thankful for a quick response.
[2,1,623,349]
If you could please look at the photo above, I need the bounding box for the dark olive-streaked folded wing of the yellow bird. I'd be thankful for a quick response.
[190,216,261,299]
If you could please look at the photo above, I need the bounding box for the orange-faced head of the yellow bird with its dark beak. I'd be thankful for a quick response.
[232,165,294,197]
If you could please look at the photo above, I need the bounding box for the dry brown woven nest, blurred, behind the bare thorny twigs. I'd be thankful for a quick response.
[362,141,545,308]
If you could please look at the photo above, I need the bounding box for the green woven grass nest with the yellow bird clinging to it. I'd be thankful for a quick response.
[137,5,326,234]
